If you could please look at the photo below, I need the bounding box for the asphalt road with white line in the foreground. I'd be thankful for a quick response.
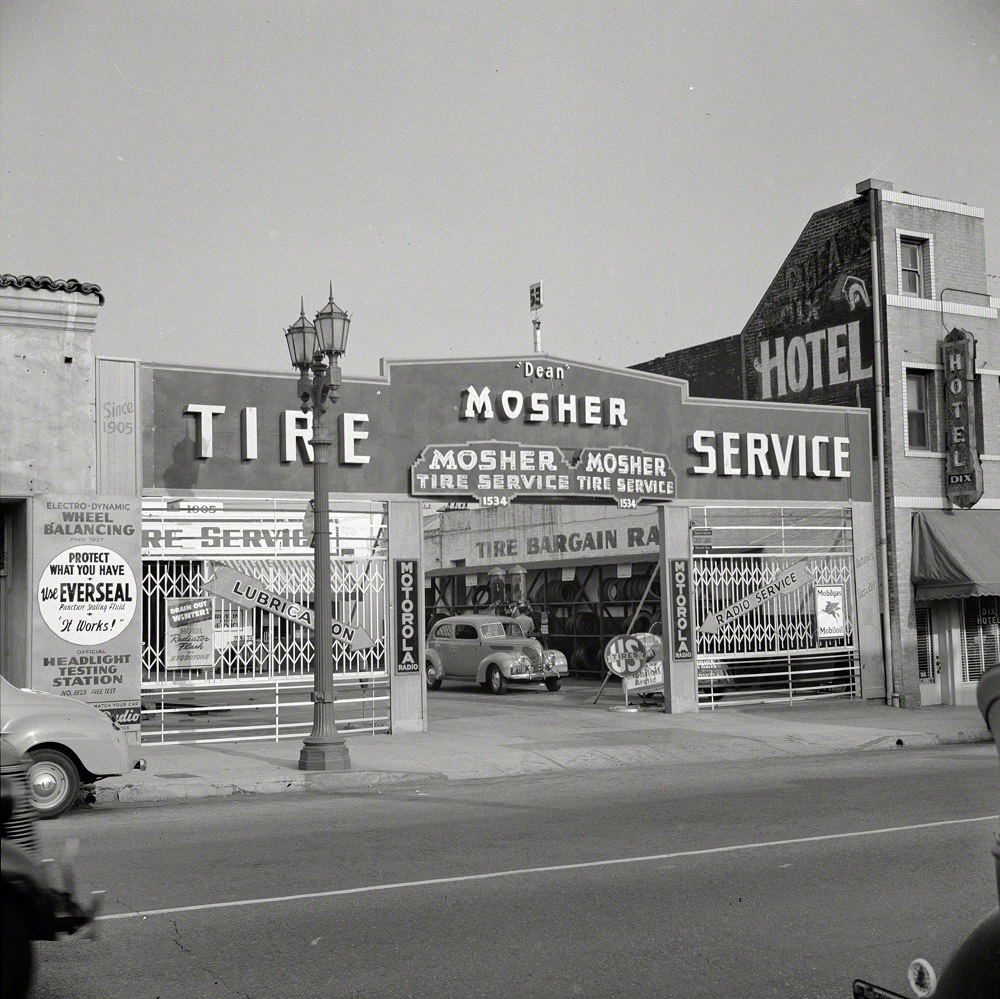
[31,745,1000,999]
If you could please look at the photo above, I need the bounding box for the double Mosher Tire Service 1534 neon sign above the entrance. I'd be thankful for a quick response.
[410,441,676,509]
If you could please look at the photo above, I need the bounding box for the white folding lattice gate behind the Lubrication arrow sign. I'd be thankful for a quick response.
[141,500,390,744]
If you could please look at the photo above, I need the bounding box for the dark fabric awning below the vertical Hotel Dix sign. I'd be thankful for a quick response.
[910,510,1000,600]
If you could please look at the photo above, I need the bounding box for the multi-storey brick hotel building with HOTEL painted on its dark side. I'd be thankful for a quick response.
[635,180,1000,707]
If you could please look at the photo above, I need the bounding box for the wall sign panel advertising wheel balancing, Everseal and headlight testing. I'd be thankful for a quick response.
[31,495,142,731]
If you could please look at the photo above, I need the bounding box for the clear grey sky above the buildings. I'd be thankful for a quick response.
[0,0,1000,378]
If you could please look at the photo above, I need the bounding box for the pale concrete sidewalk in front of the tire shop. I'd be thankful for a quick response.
[94,680,990,806]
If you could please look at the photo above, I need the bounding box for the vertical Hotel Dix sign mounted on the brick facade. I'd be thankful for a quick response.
[941,326,983,509]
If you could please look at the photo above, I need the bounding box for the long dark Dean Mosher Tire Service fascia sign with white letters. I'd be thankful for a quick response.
[142,355,871,507]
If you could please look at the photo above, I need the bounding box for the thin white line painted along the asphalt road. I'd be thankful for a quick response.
[97,815,1000,921]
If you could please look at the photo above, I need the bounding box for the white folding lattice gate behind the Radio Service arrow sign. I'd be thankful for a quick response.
[691,507,860,707]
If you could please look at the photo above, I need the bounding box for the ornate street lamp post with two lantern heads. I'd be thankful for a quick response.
[285,282,351,770]
